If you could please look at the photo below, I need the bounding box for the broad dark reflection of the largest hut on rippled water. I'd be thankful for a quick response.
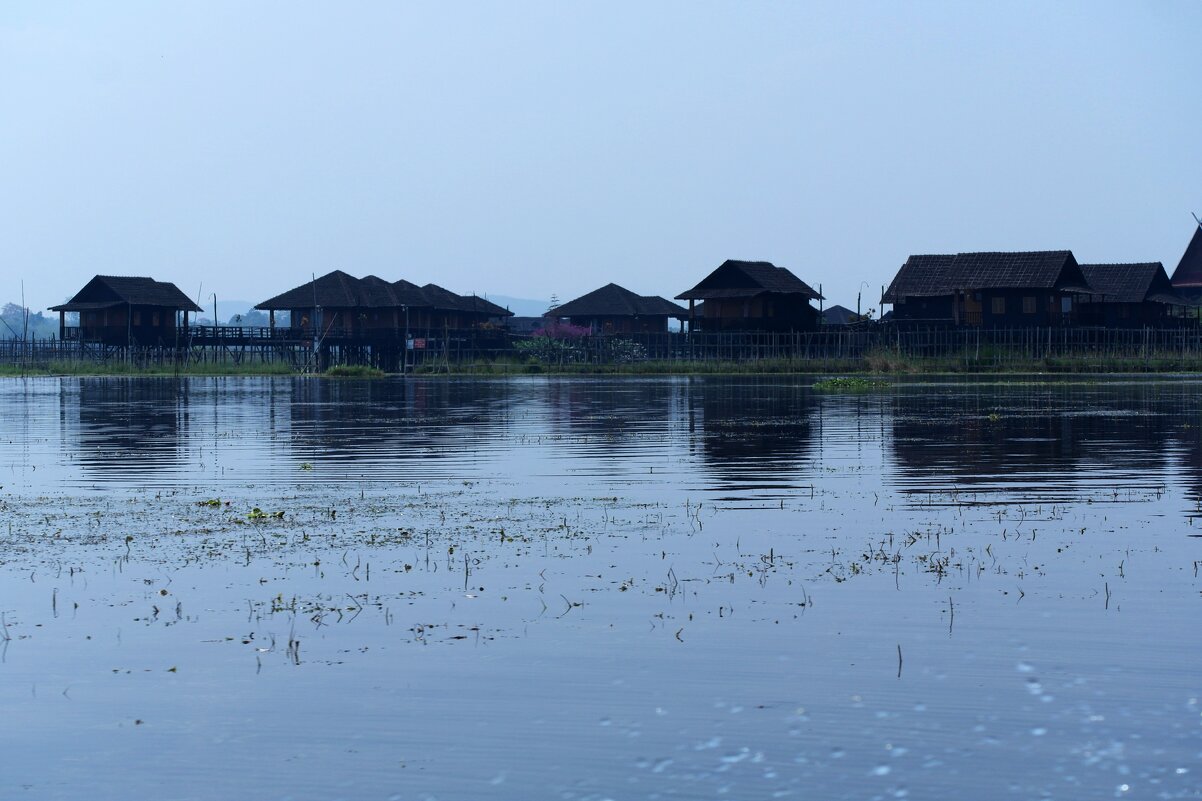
[889,382,1170,504]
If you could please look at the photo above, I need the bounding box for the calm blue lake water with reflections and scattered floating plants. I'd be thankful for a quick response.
[0,378,1202,800]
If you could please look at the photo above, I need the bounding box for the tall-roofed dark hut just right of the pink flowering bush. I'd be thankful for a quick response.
[677,260,822,332]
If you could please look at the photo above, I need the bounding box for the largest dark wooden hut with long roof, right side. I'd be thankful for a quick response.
[881,250,1091,328]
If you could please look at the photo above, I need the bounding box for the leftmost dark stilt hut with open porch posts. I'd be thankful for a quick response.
[50,275,202,346]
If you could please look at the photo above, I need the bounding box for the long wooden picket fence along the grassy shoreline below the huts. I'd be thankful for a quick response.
[7,326,1202,372]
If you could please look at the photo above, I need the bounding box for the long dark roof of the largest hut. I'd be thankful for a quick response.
[882,250,1090,303]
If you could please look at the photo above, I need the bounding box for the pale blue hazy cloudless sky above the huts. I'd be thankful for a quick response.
[0,0,1202,308]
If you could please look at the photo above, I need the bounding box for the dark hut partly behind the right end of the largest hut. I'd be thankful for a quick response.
[1077,261,1194,328]
